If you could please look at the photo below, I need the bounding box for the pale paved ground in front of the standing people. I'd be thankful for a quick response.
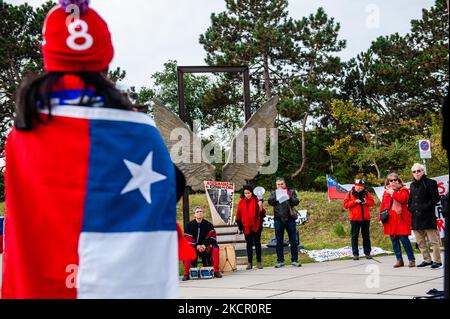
[180,255,444,299]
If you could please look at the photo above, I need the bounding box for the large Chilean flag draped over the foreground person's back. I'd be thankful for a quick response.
[2,106,178,298]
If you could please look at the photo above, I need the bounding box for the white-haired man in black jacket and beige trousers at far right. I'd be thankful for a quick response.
[408,163,442,269]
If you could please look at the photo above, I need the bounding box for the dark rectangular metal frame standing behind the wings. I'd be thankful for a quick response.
[177,66,251,227]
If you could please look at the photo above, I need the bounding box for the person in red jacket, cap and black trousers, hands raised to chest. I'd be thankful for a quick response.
[344,179,375,260]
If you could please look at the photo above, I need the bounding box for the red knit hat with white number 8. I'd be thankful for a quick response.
[42,0,114,72]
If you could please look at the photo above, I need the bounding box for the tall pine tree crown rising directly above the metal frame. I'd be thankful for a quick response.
[200,0,299,104]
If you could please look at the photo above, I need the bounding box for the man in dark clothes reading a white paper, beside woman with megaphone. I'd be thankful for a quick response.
[268,177,301,268]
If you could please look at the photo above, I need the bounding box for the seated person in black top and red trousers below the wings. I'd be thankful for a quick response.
[182,206,222,281]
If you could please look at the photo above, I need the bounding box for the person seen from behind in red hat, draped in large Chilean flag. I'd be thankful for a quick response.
[2,0,195,298]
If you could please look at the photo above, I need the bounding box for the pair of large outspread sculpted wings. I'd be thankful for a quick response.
[153,96,278,191]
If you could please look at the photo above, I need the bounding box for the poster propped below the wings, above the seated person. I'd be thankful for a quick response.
[204,181,234,225]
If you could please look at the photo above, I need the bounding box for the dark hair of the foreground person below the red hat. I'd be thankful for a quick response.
[14,72,133,131]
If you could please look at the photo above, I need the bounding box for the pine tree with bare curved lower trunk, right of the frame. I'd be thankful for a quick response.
[280,8,345,178]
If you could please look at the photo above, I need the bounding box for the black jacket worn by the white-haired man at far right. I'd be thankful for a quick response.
[408,175,440,230]
